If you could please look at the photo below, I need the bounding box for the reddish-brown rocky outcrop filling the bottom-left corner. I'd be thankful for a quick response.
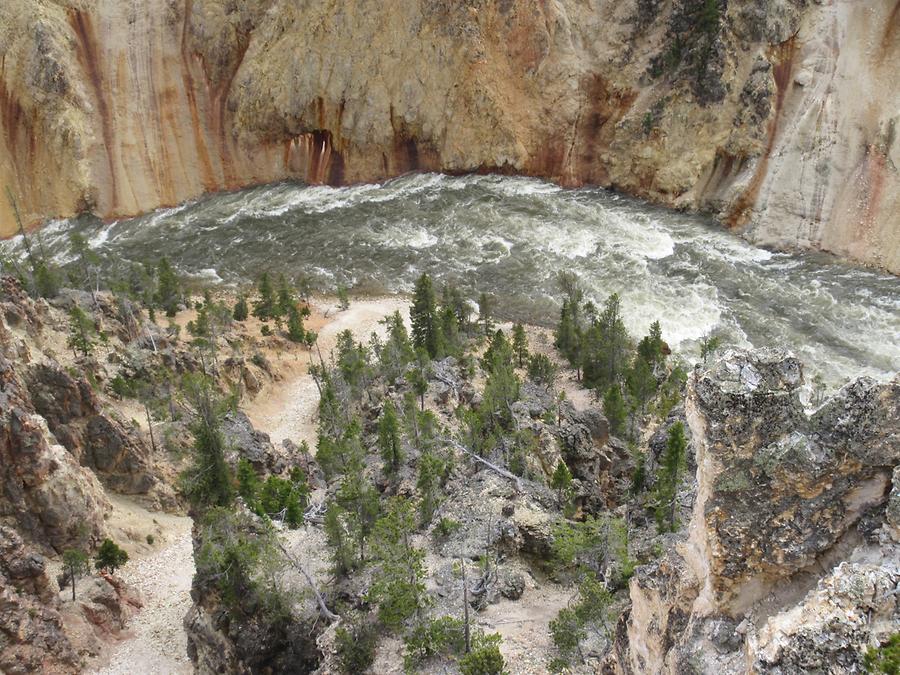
[0,525,78,675]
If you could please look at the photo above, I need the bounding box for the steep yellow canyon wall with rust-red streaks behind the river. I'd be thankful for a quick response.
[0,0,900,272]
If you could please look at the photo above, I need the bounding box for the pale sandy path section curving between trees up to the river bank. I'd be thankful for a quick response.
[244,297,409,449]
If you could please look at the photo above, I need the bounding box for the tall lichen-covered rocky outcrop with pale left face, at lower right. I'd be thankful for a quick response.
[612,350,900,673]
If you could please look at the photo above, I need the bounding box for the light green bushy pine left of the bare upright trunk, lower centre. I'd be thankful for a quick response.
[368,497,431,628]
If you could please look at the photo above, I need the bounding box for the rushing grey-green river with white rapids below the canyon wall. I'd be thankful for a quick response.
[5,174,900,394]
